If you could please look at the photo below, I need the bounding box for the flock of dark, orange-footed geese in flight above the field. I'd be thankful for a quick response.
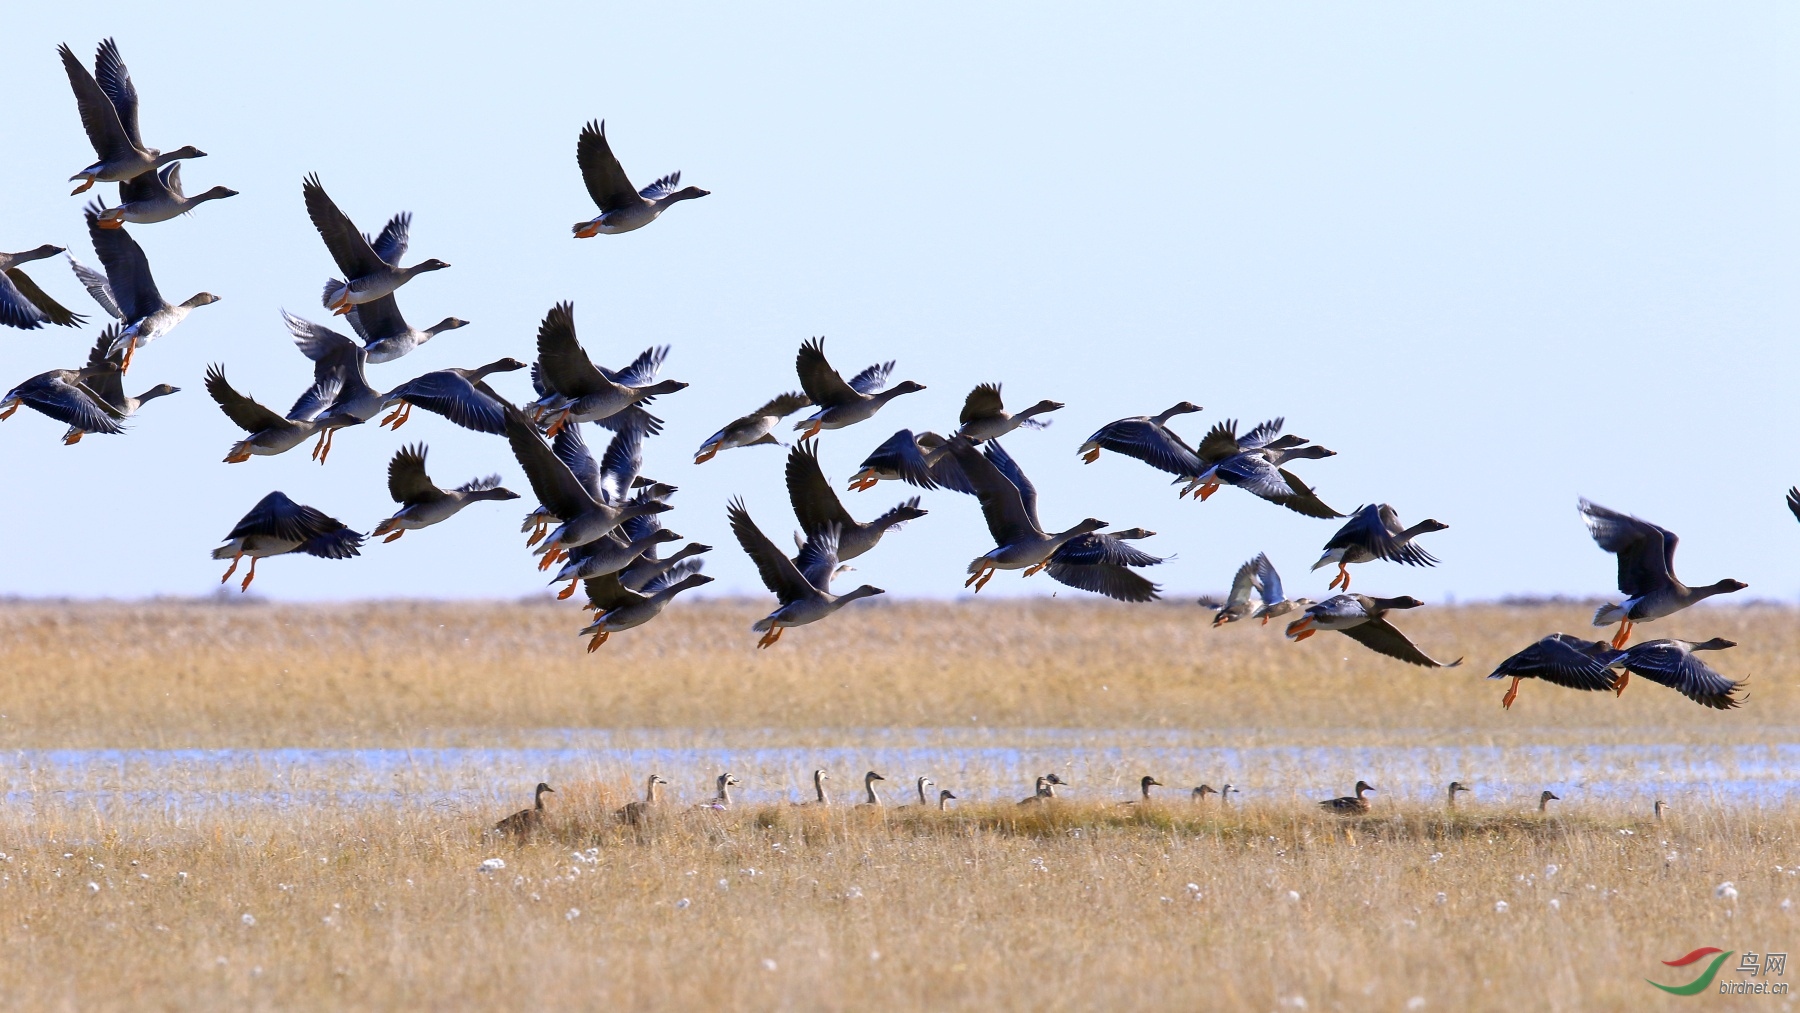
[0,40,1756,709]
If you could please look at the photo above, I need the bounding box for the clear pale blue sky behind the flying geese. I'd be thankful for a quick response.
[0,4,1800,599]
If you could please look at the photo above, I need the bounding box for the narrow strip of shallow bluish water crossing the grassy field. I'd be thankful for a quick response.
[14,729,1800,819]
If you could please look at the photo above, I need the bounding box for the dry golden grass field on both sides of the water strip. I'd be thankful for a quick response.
[0,601,1800,1009]
